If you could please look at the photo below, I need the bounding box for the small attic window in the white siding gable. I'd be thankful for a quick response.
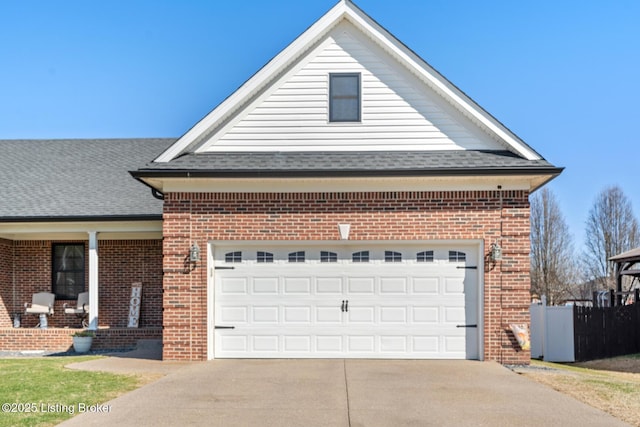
[329,73,360,122]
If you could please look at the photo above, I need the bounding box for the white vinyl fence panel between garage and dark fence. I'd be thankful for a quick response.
[529,296,575,362]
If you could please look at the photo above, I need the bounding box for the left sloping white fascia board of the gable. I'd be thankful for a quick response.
[154,1,348,163]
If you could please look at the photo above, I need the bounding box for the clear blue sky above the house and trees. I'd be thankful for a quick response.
[0,0,640,249]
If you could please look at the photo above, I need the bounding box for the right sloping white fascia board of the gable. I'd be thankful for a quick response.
[340,7,541,160]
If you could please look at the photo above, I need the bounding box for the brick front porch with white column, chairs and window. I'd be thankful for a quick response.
[0,235,163,352]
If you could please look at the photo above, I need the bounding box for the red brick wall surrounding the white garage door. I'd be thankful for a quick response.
[163,191,530,363]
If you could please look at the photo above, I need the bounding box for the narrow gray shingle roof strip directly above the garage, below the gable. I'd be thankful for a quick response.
[134,150,561,177]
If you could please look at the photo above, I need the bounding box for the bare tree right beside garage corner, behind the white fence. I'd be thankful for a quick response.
[531,188,576,305]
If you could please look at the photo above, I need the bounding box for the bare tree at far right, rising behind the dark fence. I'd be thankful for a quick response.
[584,185,640,289]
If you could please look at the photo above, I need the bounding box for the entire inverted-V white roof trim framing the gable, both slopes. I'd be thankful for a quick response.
[154,0,541,163]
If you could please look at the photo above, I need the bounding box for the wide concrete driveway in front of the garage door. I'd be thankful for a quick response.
[61,360,626,427]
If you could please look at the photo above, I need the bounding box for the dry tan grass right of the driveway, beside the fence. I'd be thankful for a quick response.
[520,354,640,426]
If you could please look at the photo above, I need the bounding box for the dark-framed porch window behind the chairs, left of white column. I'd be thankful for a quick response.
[51,243,85,300]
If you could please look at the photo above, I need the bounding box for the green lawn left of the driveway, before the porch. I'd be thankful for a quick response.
[0,356,139,427]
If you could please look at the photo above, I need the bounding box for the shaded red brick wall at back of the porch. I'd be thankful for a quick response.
[0,240,162,328]
